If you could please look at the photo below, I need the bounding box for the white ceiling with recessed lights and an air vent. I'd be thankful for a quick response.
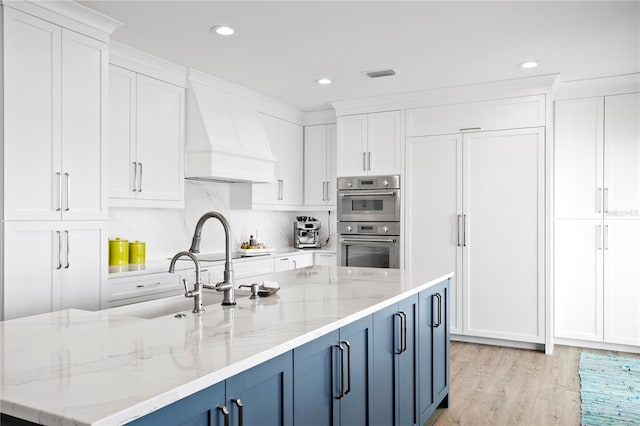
[81,1,640,111]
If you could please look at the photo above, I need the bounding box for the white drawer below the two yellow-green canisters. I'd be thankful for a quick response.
[108,272,183,302]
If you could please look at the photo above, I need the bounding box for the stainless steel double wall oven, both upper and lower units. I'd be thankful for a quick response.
[337,175,400,268]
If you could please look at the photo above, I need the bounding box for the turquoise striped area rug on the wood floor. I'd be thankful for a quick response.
[579,352,640,426]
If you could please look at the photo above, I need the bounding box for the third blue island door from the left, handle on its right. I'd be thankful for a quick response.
[293,330,342,426]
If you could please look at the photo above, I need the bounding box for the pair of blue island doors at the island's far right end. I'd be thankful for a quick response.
[418,280,449,425]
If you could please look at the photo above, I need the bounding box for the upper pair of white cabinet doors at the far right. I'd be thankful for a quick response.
[555,93,640,219]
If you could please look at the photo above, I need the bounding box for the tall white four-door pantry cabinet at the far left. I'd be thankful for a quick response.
[0,2,119,320]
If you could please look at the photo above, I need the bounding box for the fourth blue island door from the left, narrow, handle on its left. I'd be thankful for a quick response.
[339,316,373,426]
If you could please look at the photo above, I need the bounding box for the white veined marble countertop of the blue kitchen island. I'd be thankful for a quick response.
[0,266,453,425]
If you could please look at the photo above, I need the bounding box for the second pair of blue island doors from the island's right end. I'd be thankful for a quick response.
[371,294,419,426]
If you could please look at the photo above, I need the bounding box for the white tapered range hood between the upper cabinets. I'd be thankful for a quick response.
[185,70,276,182]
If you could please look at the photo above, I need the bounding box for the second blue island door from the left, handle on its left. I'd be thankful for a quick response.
[225,351,293,426]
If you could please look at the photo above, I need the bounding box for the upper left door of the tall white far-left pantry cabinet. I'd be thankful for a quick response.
[2,7,61,220]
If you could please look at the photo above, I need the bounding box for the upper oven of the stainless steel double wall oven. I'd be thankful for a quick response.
[337,176,400,222]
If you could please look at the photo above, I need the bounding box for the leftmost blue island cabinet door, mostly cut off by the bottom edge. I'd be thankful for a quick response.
[128,382,226,426]
